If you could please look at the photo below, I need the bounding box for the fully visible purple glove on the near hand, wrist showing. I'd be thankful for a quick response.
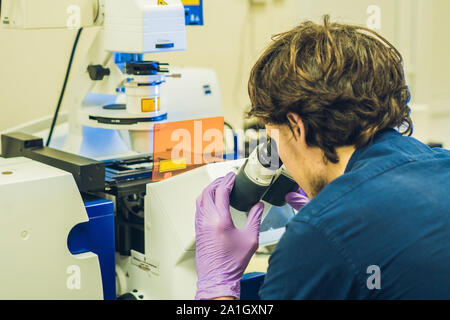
[195,172,264,299]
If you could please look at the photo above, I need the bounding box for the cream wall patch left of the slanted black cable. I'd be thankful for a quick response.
[0,28,76,131]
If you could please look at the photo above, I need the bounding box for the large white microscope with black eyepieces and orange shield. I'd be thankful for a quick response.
[0,0,296,300]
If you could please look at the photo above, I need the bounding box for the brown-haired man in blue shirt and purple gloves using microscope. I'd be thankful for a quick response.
[196,16,450,299]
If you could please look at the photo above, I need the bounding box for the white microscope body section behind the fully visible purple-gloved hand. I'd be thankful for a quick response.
[142,159,284,299]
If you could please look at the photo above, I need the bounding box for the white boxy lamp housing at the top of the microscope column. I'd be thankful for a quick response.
[104,0,186,53]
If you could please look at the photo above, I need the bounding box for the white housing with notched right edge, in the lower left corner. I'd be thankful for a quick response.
[0,157,103,300]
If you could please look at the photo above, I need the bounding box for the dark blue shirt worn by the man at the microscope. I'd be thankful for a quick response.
[260,130,450,299]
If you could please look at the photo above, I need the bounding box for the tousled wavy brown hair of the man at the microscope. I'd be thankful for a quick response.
[247,15,413,163]
